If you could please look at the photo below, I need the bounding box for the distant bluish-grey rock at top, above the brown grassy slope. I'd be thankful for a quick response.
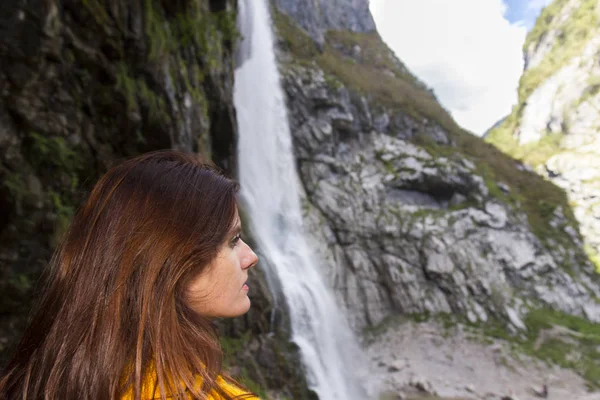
[275,0,375,45]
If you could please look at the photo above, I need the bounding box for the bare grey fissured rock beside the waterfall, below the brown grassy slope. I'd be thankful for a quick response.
[284,66,600,329]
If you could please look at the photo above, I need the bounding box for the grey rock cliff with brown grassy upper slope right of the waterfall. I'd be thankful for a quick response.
[280,3,600,328]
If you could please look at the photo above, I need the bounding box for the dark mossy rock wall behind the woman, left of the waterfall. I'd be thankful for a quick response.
[0,0,240,362]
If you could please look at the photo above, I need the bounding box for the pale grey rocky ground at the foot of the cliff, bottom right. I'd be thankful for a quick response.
[366,321,600,400]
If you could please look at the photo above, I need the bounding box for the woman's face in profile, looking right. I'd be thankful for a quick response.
[186,212,258,318]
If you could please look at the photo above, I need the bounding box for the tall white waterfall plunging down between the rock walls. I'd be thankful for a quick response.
[234,0,366,400]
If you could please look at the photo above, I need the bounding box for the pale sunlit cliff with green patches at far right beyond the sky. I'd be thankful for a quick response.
[488,0,600,269]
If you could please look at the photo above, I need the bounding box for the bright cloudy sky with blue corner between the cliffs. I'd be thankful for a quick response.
[370,0,550,135]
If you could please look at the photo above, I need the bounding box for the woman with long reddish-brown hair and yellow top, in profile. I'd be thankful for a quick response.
[0,151,258,400]
